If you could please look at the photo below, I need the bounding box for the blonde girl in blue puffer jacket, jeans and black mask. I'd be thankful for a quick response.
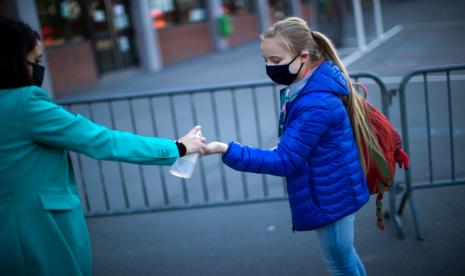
[206,17,379,275]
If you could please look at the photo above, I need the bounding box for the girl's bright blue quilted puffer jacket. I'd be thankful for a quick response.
[223,61,369,231]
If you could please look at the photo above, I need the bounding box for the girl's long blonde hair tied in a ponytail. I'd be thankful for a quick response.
[260,17,383,173]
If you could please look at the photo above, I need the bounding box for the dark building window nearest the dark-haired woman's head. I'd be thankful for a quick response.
[37,0,85,46]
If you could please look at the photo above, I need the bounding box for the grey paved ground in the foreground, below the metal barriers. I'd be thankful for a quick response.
[88,186,465,276]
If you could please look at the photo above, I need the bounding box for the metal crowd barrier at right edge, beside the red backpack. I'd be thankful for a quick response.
[391,64,465,240]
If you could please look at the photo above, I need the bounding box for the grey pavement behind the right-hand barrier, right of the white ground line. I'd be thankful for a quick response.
[349,20,465,77]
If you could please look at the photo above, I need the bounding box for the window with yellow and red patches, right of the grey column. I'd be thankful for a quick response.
[149,0,207,29]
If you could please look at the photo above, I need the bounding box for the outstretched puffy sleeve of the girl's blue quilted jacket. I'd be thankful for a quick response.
[223,99,331,176]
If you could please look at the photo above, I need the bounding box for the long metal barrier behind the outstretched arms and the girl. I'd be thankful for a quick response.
[60,73,390,217]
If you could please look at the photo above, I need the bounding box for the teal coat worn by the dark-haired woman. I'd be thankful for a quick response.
[0,86,179,276]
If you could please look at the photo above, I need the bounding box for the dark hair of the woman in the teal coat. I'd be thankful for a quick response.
[0,16,40,89]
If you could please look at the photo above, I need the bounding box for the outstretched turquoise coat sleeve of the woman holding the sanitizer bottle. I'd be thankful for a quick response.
[22,87,179,165]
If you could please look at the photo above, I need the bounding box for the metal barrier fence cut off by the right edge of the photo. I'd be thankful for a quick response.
[391,64,465,240]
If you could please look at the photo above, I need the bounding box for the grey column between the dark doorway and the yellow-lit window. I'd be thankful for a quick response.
[130,0,163,72]
